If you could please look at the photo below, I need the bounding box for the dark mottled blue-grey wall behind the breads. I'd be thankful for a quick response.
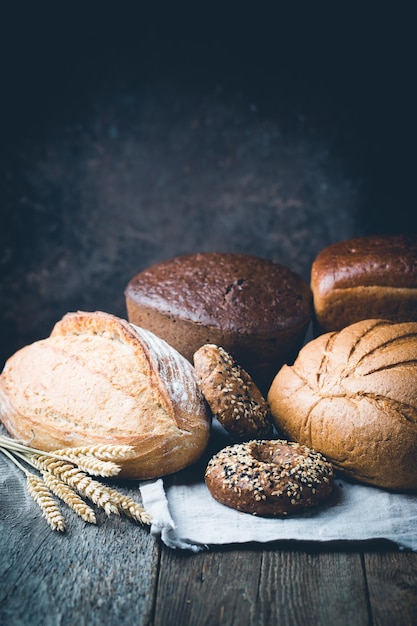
[0,2,416,364]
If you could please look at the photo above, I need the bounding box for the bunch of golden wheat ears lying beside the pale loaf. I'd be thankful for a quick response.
[0,436,151,531]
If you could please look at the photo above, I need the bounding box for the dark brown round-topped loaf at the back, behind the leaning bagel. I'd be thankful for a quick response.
[125,253,312,393]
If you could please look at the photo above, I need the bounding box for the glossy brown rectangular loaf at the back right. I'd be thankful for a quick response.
[311,235,417,334]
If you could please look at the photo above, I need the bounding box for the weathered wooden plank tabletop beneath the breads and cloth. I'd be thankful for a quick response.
[0,448,417,626]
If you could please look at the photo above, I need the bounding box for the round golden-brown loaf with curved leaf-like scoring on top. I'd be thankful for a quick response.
[268,320,417,490]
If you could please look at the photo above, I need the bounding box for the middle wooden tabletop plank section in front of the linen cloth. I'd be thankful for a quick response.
[155,546,369,626]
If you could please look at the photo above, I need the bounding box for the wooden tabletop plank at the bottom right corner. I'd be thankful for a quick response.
[364,551,417,626]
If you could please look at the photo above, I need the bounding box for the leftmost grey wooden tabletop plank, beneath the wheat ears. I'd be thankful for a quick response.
[0,455,159,626]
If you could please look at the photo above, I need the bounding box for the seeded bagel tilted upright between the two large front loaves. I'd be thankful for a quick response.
[194,344,272,440]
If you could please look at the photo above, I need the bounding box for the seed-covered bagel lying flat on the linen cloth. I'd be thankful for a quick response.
[205,439,334,517]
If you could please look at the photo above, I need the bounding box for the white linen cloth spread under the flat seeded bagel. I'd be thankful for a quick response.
[140,423,417,552]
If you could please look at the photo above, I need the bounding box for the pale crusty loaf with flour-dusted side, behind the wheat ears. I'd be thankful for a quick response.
[0,312,210,479]
